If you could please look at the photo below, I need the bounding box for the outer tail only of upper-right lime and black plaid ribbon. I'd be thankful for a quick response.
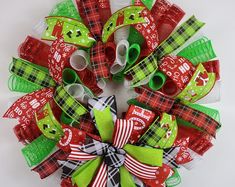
[153,16,205,59]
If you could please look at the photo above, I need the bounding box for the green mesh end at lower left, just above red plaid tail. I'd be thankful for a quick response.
[21,135,57,167]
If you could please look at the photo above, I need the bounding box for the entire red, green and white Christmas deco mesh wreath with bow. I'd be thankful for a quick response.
[4,0,221,187]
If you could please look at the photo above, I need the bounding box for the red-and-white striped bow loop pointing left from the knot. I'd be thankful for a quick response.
[68,144,97,161]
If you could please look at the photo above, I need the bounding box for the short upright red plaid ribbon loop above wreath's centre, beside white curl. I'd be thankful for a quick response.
[90,42,109,80]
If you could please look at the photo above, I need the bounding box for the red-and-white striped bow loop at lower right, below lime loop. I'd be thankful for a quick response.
[124,154,158,179]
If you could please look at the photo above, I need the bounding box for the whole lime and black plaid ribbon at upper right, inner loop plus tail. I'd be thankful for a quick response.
[125,16,205,87]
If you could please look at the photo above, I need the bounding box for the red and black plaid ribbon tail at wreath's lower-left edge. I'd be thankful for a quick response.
[32,149,68,179]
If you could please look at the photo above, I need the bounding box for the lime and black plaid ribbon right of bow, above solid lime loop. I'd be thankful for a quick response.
[138,121,167,147]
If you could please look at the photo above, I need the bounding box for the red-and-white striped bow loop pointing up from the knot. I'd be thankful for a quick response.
[113,119,134,148]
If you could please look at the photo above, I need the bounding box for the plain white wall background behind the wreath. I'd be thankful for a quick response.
[0,0,235,187]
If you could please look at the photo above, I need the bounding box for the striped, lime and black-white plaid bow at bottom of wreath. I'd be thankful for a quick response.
[68,105,163,187]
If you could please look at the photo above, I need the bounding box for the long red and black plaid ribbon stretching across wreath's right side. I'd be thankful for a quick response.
[137,88,220,137]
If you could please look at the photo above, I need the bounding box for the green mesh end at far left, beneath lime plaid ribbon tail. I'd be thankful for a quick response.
[8,75,42,93]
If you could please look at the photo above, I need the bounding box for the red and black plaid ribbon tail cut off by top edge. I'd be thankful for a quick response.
[77,0,103,41]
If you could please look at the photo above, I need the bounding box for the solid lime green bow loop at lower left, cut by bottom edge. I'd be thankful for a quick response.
[72,157,102,187]
